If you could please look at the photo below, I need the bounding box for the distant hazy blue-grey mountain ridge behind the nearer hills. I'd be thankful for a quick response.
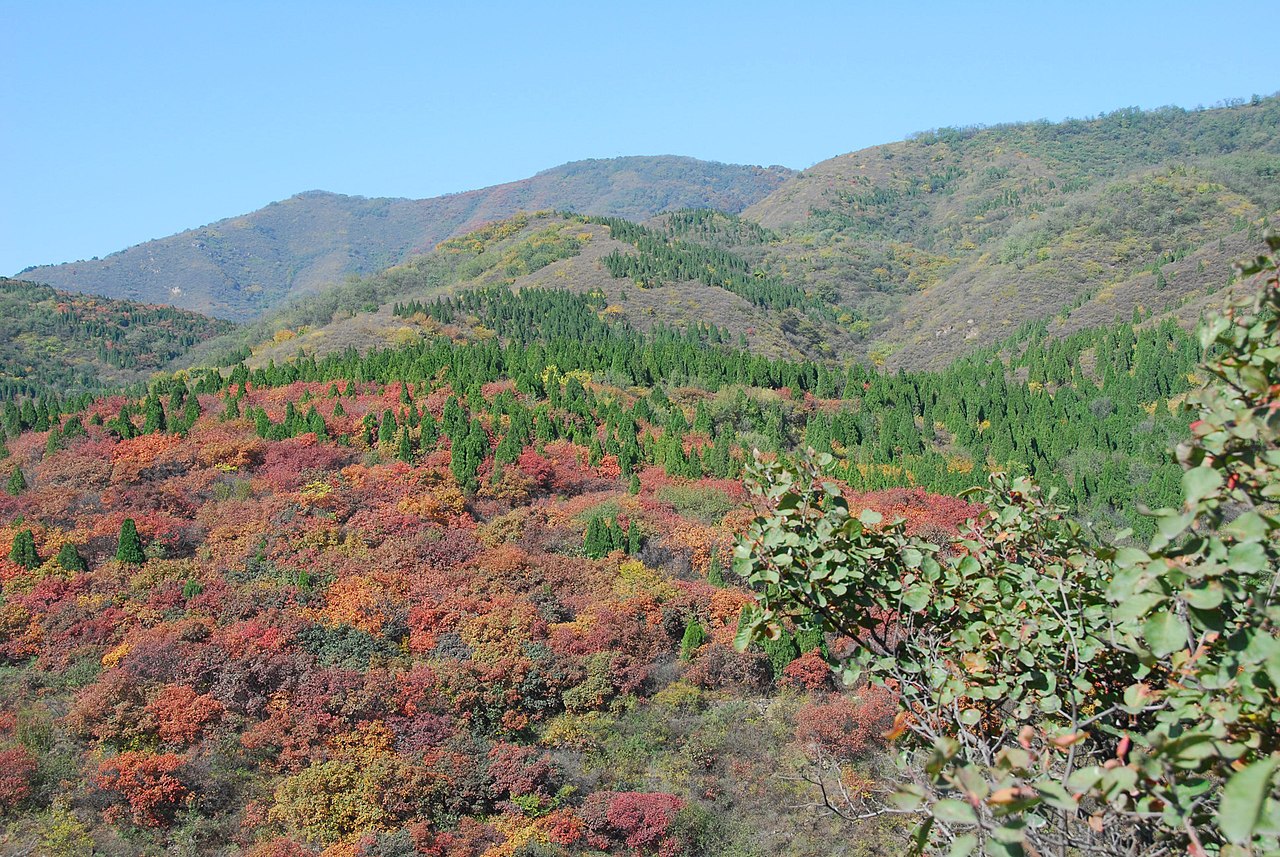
[20,156,792,321]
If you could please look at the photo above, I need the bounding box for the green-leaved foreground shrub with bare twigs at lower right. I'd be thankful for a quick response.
[735,238,1280,857]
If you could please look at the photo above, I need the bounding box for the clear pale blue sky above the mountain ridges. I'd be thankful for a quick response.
[0,0,1280,272]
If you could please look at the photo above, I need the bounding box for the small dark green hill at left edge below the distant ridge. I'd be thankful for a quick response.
[0,278,232,398]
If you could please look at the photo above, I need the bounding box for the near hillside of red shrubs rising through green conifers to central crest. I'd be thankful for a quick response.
[0,241,1239,857]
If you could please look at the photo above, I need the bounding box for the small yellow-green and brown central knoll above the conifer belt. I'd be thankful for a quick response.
[179,211,856,366]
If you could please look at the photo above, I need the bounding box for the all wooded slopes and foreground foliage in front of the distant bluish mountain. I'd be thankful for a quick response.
[0,98,1280,857]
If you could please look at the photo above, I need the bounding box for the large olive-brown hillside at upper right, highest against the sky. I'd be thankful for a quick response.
[742,97,1280,367]
